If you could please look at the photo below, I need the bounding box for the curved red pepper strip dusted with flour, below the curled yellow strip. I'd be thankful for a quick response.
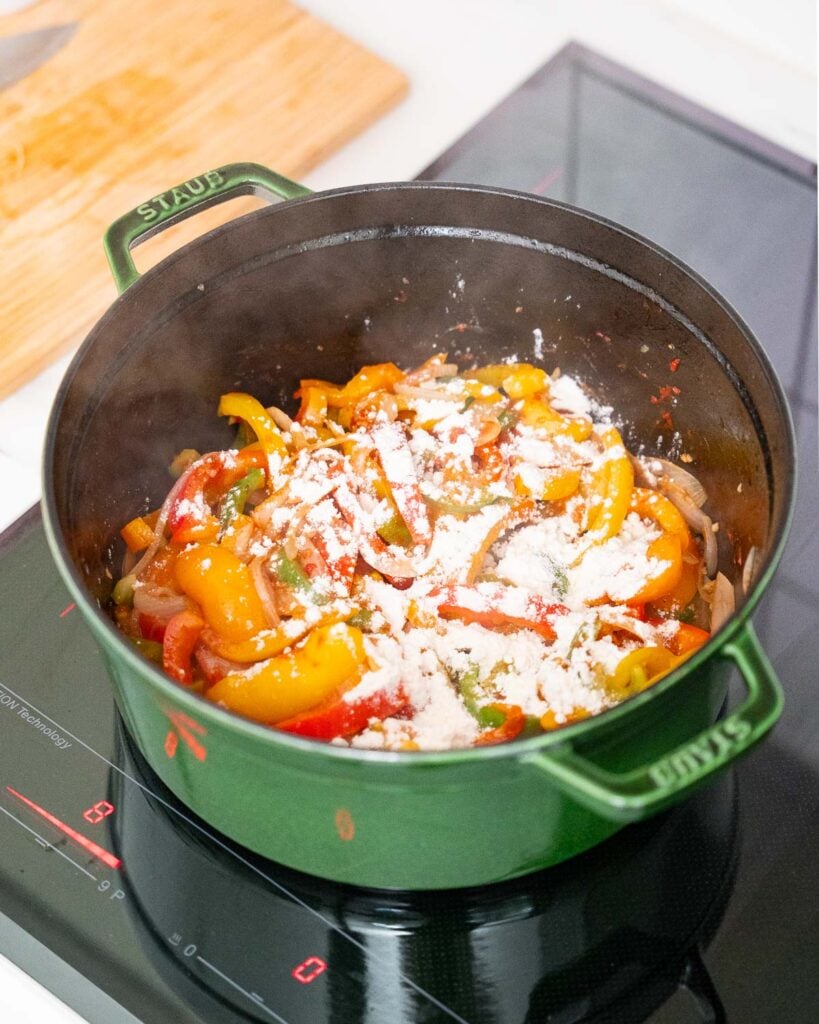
[168,444,267,544]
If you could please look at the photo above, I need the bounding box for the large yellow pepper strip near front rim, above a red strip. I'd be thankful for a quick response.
[206,623,367,725]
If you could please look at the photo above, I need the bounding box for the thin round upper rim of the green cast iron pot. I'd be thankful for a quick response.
[42,181,796,768]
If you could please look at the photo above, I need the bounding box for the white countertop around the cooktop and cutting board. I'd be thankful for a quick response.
[0,0,817,1024]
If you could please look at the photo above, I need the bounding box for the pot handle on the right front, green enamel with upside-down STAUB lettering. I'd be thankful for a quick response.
[522,623,783,821]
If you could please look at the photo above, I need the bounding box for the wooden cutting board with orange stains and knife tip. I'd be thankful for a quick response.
[0,0,406,397]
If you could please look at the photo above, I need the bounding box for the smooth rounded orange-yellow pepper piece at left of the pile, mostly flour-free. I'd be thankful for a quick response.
[174,544,269,640]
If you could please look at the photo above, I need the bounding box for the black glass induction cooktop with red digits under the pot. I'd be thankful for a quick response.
[0,46,819,1024]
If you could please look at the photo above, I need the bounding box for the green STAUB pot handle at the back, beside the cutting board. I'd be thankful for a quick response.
[102,164,310,294]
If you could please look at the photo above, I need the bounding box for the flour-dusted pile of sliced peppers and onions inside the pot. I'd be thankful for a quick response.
[114,354,724,751]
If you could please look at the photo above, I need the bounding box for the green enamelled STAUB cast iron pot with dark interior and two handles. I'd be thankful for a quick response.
[44,164,794,889]
